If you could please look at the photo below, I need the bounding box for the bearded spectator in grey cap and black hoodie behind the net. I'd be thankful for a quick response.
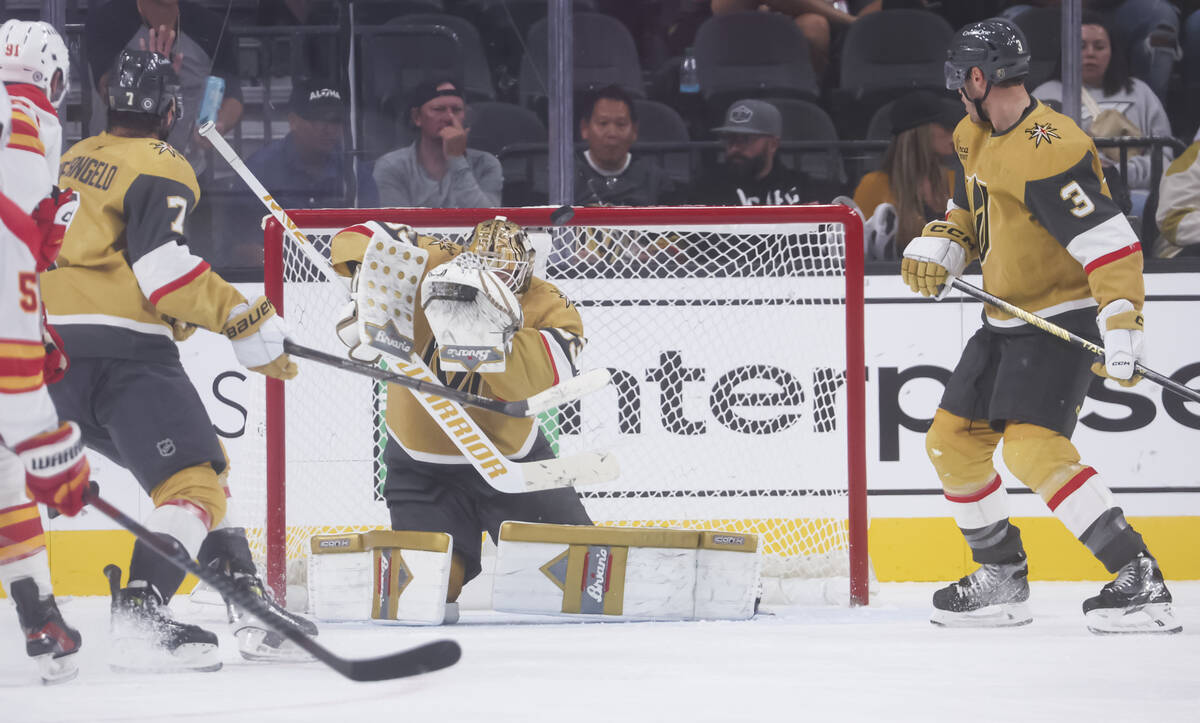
[689,100,836,205]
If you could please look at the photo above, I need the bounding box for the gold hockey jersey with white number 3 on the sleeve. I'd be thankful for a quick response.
[947,101,1145,328]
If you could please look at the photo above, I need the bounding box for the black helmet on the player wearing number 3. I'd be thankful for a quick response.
[946,18,1030,90]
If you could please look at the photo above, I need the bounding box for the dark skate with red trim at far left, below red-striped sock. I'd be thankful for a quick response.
[8,578,82,686]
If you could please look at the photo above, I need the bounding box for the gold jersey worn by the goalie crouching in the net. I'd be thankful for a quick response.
[331,225,584,464]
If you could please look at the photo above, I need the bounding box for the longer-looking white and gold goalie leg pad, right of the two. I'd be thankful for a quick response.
[492,522,761,620]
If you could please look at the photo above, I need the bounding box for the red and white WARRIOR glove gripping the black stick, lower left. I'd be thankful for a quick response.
[13,422,91,516]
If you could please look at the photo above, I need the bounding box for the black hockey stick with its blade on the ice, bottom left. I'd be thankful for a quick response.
[84,491,462,681]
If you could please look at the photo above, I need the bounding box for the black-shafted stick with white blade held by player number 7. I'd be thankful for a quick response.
[283,341,612,417]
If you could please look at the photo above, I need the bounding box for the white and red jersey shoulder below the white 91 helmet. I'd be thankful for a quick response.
[0,83,62,214]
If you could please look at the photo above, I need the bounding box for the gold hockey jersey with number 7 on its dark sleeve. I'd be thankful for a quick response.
[42,132,246,360]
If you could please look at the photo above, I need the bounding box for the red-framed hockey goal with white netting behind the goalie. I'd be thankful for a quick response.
[253,205,869,604]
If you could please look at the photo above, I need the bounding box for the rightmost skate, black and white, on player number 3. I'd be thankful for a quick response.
[1084,552,1183,634]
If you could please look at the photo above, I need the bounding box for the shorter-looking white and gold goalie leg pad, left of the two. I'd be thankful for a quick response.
[308,530,454,625]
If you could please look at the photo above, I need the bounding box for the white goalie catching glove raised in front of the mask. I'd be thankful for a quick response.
[421,252,524,372]
